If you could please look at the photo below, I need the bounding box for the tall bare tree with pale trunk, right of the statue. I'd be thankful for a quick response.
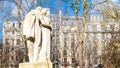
[65,0,108,68]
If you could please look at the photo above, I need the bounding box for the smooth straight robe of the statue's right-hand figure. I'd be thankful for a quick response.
[38,9,51,62]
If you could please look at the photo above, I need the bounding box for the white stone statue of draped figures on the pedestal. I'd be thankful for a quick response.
[23,7,51,62]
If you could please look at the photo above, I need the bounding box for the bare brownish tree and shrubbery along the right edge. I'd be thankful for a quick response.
[102,2,120,68]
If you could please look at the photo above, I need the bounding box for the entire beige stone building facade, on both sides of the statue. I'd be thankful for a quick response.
[2,12,117,68]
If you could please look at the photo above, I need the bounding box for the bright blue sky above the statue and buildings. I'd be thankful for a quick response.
[0,0,120,40]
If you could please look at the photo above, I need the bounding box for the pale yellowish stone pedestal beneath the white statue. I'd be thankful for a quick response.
[19,62,53,68]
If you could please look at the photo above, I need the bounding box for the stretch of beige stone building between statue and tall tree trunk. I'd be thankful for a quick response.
[51,11,81,68]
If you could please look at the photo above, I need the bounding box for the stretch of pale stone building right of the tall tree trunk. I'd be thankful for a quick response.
[86,14,118,65]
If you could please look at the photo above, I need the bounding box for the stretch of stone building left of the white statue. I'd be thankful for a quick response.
[2,21,22,68]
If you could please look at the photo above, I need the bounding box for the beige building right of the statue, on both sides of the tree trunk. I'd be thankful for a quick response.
[51,12,119,68]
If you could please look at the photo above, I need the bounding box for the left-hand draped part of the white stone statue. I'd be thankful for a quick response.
[23,10,35,62]
